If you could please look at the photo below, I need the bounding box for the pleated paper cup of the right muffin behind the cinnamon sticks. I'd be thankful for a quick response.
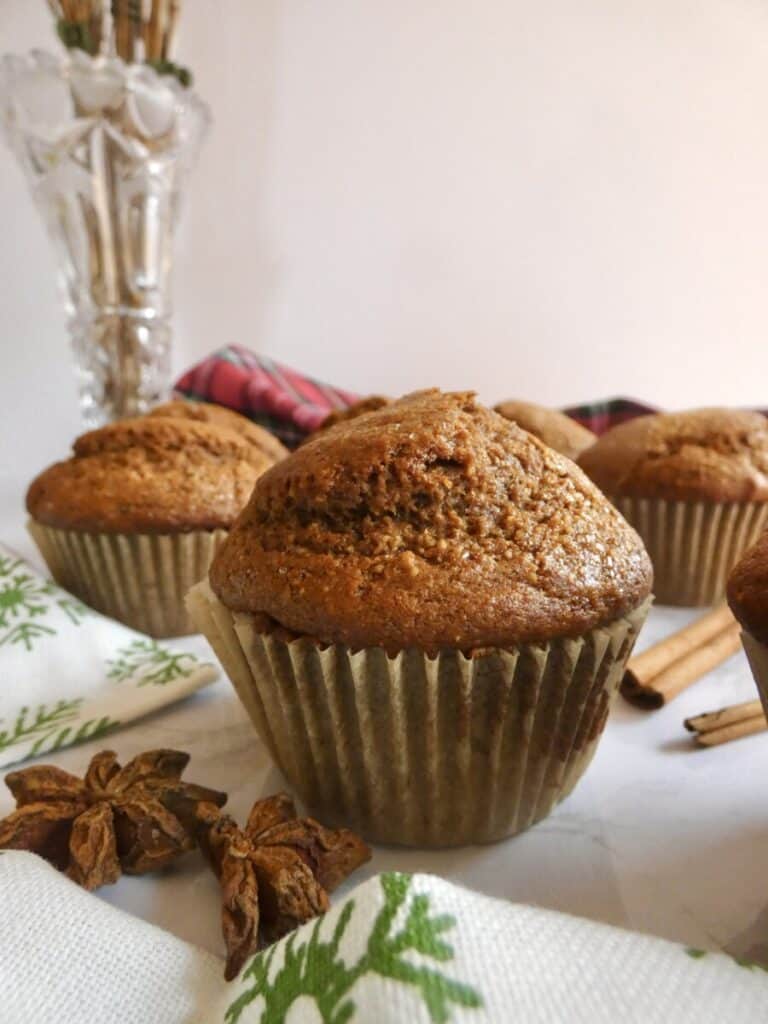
[611,498,768,606]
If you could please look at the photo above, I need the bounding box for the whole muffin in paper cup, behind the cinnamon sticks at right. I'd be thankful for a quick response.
[579,409,768,605]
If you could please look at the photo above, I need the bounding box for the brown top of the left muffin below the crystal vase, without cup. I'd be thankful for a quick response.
[27,416,273,534]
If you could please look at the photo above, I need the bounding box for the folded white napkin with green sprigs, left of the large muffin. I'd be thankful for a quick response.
[0,544,218,767]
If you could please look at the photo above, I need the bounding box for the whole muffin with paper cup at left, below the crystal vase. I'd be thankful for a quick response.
[27,416,286,637]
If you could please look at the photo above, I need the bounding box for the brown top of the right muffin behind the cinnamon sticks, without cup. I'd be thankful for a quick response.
[579,409,768,502]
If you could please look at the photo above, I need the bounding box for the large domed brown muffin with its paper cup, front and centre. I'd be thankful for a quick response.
[187,390,651,846]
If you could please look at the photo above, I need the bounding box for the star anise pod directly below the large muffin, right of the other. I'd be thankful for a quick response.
[165,793,371,981]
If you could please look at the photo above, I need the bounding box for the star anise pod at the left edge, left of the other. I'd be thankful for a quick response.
[0,750,226,890]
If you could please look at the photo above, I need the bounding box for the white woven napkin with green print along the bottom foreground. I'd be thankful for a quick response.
[0,852,768,1024]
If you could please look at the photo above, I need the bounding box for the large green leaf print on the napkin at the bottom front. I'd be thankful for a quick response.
[225,873,482,1024]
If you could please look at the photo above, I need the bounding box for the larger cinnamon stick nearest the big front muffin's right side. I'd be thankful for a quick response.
[621,604,740,711]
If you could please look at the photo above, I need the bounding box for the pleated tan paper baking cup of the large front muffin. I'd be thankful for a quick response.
[187,582,650,847]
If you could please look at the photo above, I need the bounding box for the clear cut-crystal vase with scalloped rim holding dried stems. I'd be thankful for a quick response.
[0,50,210,426]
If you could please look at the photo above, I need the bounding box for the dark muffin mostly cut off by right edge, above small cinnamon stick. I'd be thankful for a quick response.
[727,531,768,715]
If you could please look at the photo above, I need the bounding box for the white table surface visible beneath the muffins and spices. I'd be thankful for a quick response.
[0,475,768,964]
